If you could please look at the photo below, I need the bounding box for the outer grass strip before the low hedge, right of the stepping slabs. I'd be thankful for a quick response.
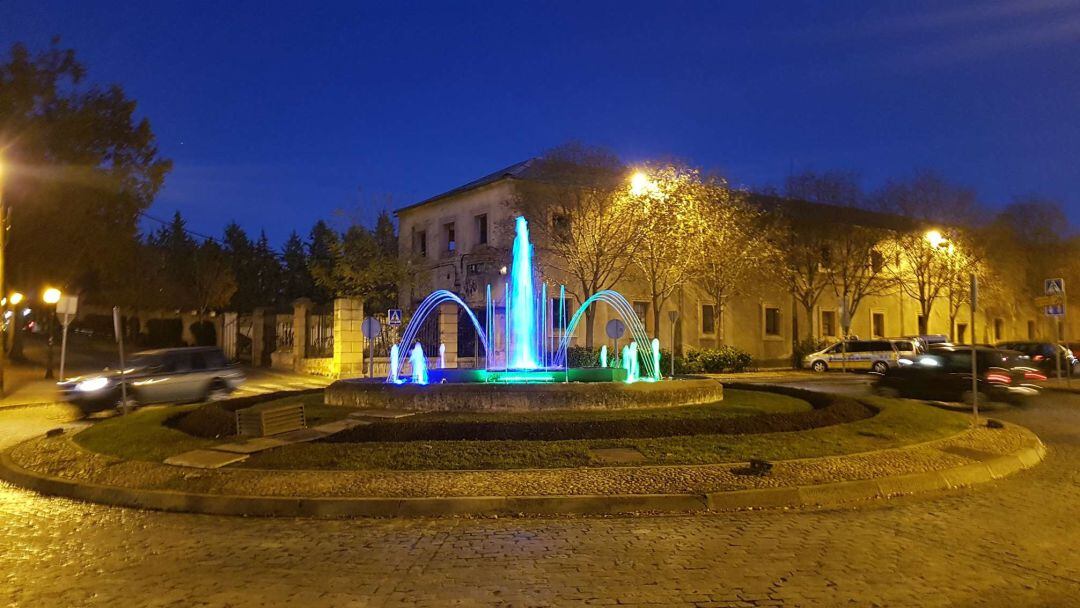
[240,390,969,470]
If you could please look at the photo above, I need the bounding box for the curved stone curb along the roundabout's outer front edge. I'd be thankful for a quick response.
[0,427,1047,518]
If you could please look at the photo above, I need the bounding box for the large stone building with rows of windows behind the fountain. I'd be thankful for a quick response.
[396,161,1052,366]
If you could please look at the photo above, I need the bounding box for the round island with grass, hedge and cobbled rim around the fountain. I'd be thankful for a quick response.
[0,387,1044,517]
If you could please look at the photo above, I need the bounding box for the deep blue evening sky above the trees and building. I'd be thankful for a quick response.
[6,0,1080,244]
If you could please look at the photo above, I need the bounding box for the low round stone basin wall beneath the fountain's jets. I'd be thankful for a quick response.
[324,375,724,411]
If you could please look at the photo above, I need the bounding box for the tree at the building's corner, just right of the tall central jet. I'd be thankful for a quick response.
[513,144,645,348]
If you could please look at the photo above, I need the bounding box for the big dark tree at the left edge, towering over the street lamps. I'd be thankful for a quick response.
[0,40,172,294]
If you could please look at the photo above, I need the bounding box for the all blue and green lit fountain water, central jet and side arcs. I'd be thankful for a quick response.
[387,217,661,384]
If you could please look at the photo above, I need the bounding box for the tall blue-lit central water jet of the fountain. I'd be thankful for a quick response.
[507,217,539,369]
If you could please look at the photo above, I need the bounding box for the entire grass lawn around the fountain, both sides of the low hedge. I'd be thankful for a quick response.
[76,390,969,470]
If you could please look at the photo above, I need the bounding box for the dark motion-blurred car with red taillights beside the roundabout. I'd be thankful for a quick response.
[874,346,1047,403]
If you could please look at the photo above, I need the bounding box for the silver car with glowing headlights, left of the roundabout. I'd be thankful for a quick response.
[57,347,244,411]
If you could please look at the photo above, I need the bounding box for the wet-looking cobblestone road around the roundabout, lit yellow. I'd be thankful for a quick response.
[0,395,1080,607]
